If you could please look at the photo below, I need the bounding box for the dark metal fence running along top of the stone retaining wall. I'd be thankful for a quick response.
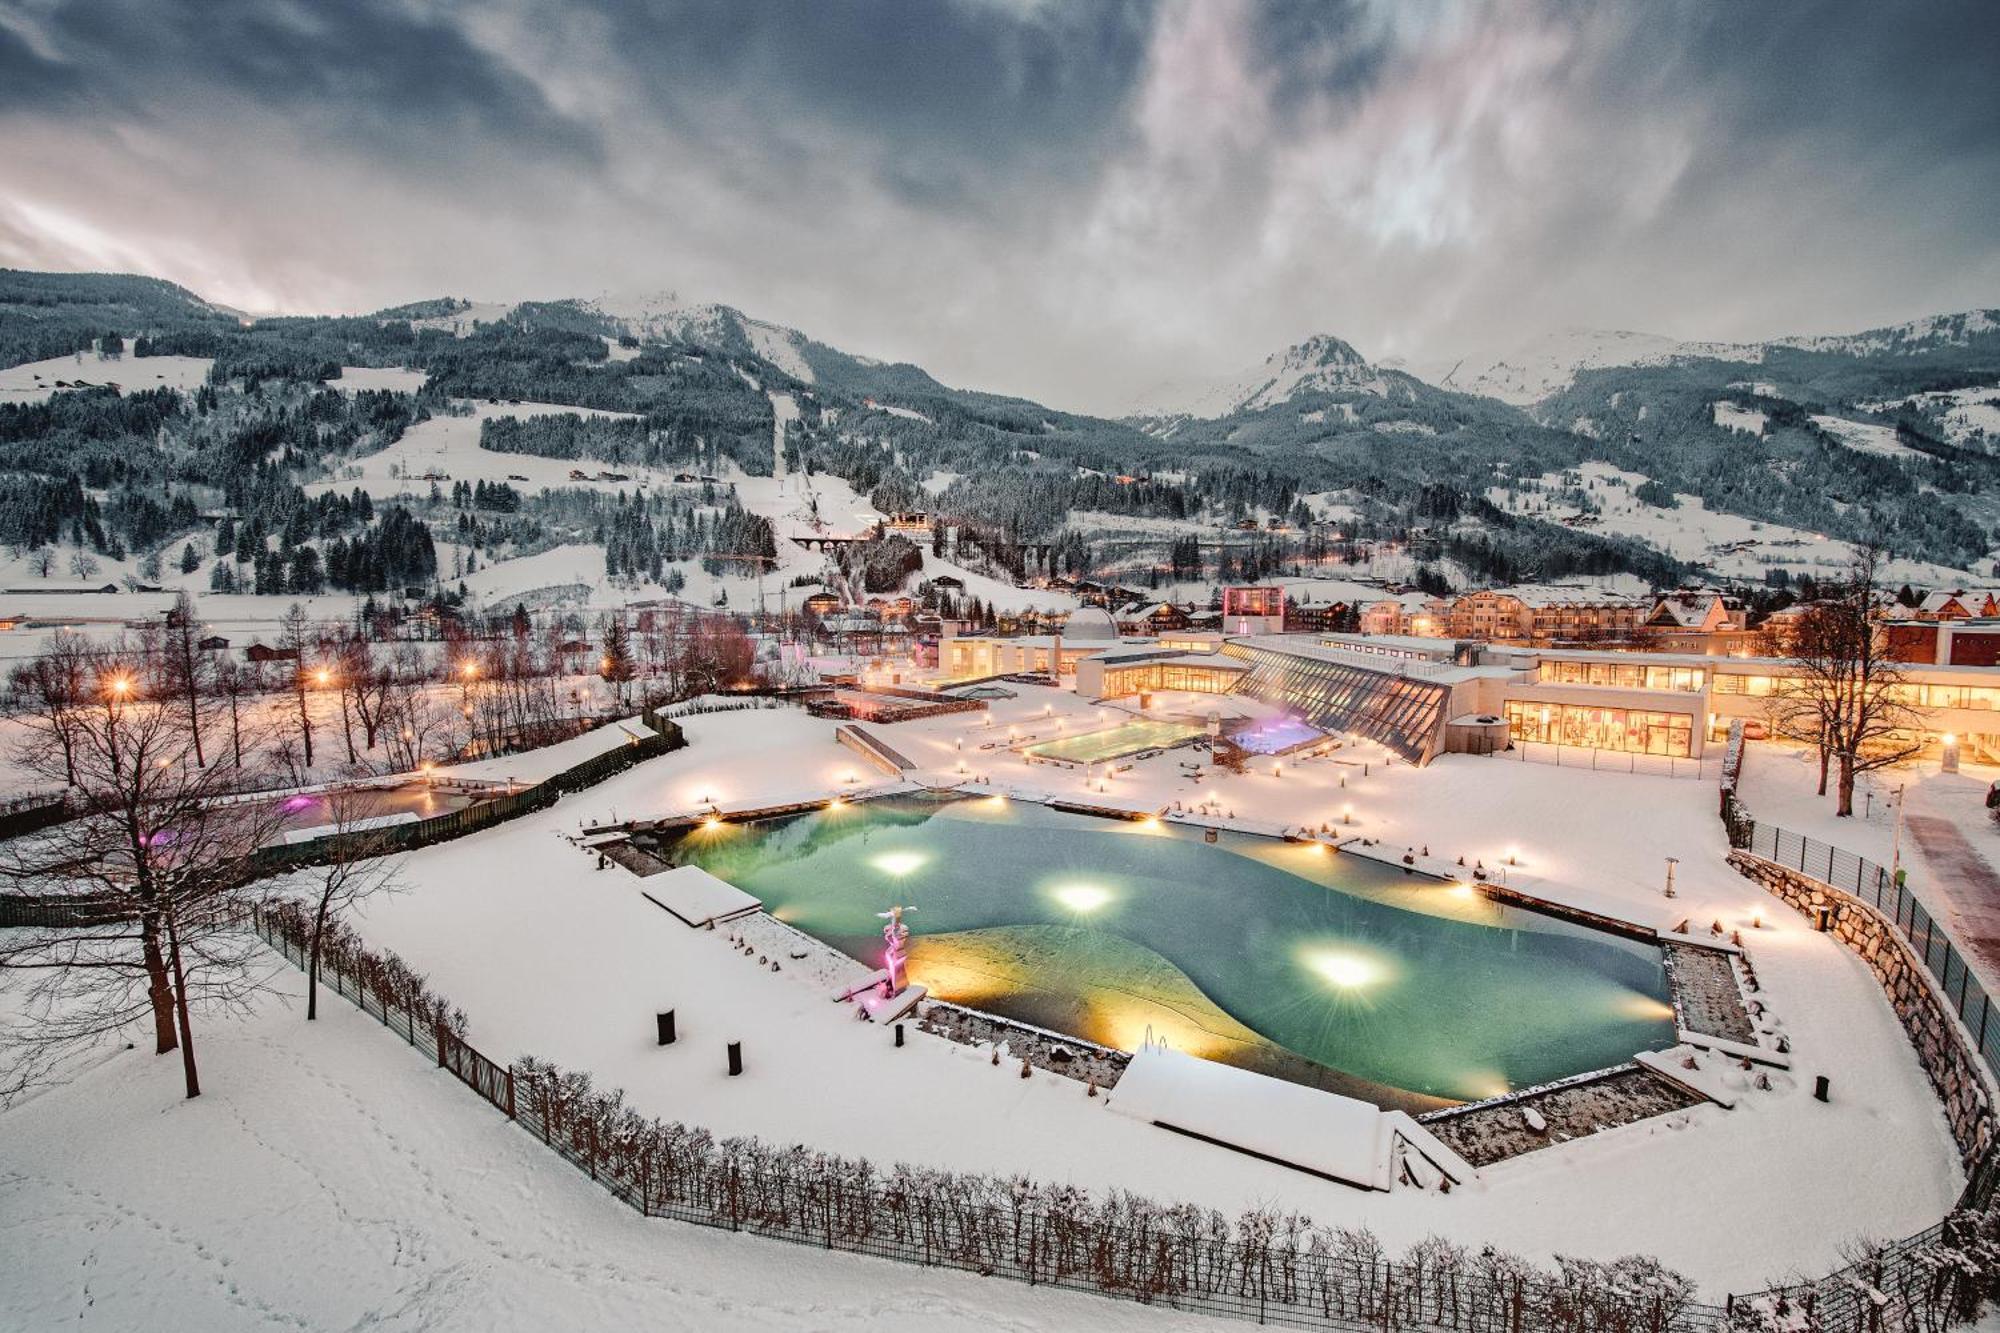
[1730,819,2000,1081]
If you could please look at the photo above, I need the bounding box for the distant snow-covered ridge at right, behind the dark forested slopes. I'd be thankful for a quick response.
[1436,310,2000,406]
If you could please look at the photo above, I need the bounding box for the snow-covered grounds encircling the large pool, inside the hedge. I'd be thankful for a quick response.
[304,691,1960,1293]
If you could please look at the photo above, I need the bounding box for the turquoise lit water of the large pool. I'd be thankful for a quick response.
[676,799,1674,1101]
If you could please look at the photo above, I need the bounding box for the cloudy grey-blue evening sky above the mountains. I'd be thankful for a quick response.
[0,0,2000,412]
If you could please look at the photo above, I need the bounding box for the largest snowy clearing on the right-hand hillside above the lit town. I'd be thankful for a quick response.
[1486,462,1972,588]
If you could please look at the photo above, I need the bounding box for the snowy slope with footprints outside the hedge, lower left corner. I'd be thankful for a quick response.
[0,959,1224,1333]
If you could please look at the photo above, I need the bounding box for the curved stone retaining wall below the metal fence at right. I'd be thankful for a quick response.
[1730,851,1996,1163]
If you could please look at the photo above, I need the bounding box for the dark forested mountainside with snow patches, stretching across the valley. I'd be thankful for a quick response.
[0,272,2000,590]
